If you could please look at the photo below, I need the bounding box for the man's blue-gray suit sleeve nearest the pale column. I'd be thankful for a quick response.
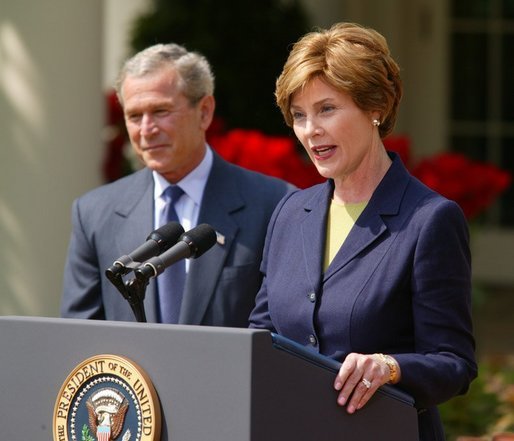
[61,199,105,319]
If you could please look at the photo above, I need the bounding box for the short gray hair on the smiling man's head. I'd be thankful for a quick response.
[114,43,214,104]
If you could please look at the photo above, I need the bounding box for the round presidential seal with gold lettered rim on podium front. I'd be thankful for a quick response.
[53,355,161,441]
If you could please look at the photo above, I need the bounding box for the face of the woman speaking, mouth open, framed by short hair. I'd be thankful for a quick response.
[290,78,380,185]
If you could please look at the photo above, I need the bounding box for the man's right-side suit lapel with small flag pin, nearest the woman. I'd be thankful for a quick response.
[179,153,242,324]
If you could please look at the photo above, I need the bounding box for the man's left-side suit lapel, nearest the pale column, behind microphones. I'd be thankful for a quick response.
[113,168,157,323]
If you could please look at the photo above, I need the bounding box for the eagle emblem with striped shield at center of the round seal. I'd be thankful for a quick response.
[86,387,128,441]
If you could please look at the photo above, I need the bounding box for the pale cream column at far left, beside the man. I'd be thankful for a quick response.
[0,0,104,316]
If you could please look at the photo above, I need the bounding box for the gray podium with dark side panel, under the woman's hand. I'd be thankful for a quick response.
[0,317,418,441]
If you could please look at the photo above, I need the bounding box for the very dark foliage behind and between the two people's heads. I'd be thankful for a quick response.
[131,0,308,134]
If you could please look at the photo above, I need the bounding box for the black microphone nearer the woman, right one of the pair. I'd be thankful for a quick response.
[134,224,216,280]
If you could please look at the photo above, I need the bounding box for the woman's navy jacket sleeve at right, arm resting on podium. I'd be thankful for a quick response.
[395,201,477,406]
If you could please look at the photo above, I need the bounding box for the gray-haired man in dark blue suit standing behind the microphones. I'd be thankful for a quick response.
[61,44,290,327]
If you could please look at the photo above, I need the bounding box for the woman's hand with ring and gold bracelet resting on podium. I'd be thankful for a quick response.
[334,353,399,413]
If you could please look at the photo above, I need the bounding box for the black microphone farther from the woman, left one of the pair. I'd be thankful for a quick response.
[105,222,184,280]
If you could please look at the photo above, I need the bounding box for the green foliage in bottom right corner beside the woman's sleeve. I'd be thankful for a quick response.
[439,357,514,441]
